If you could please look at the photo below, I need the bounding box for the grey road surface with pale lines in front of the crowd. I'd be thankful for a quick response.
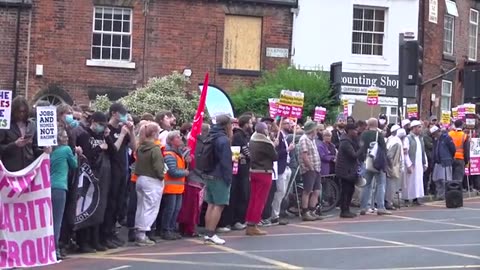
[37,197,480,270]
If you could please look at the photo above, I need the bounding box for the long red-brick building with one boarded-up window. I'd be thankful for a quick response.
[0,0,296,104]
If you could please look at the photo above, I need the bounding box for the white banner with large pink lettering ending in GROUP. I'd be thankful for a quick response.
[0,154,57,269]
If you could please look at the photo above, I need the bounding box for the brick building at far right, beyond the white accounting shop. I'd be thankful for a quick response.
[419,0,480,117]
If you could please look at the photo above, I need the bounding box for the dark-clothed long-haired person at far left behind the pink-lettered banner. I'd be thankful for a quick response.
[0,96,42,172]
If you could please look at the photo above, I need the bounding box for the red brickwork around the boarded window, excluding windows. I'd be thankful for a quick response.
[0,0,292,104]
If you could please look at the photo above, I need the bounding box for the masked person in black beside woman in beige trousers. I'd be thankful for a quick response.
[101,103,137,248]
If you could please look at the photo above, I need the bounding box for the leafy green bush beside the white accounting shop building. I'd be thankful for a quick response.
[230,66,339,123]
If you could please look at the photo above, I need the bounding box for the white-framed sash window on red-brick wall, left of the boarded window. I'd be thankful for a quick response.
[92,7,132,62]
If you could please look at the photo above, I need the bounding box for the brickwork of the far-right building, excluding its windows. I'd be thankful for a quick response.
[421,0,480,117]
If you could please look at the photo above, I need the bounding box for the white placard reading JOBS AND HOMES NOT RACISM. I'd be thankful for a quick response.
[37,106,58,146]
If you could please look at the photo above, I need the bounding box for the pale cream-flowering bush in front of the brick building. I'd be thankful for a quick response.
[93,72,199,125]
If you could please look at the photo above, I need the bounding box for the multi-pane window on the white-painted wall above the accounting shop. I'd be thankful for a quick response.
[352,6,385,55]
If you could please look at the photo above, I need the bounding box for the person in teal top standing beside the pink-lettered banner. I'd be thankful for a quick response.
[50,128,82,259]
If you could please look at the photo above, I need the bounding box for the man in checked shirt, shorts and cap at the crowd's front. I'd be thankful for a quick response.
[298,121,322,221]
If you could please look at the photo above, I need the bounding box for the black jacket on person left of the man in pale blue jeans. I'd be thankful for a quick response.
[335,134,362,182]
